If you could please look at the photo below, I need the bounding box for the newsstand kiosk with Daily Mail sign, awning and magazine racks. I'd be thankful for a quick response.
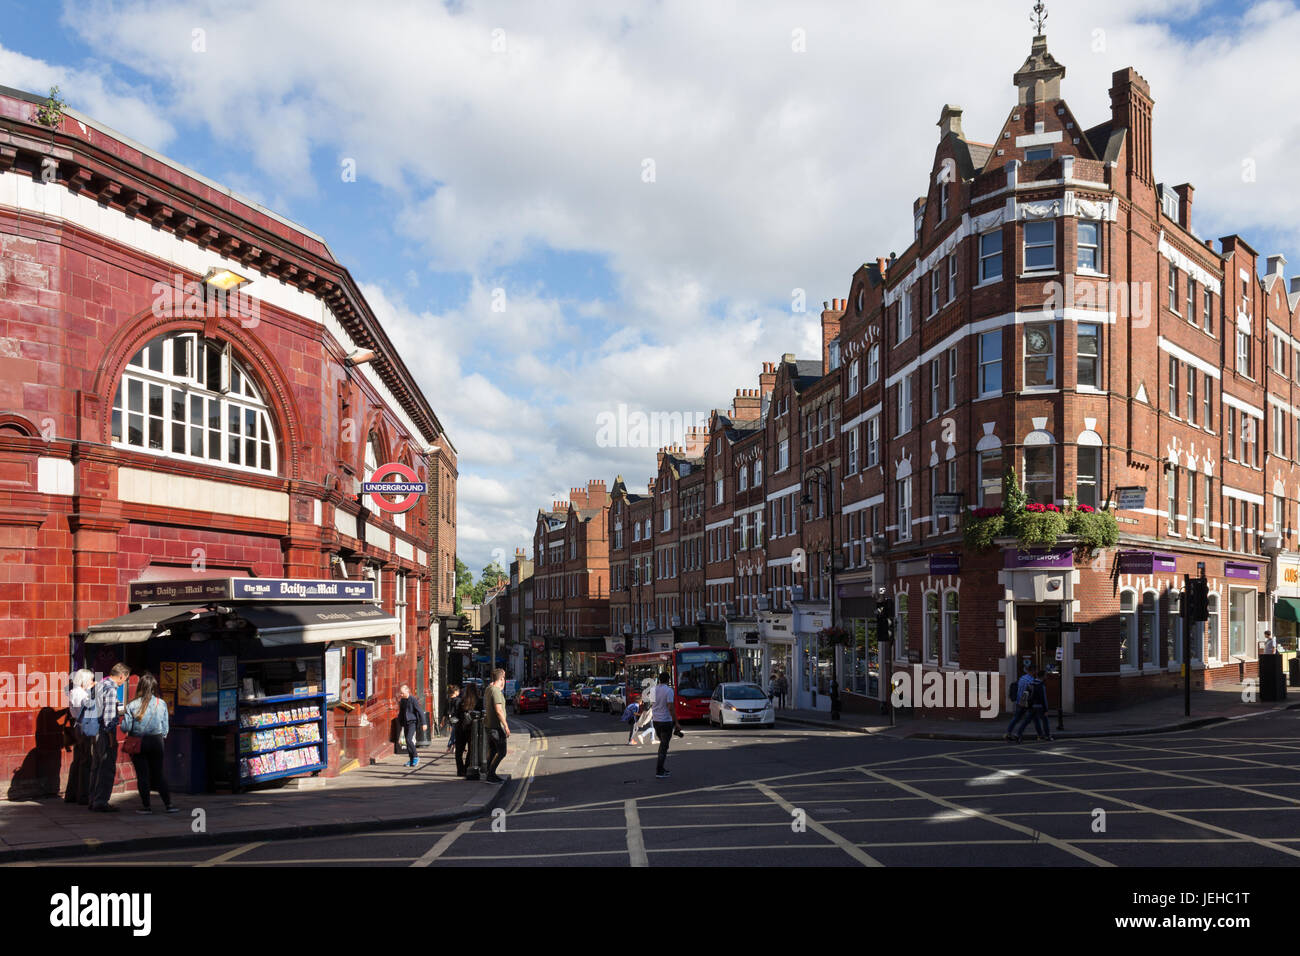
[78,578,398,793]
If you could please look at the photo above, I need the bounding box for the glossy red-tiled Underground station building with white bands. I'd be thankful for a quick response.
[0,90,456,793]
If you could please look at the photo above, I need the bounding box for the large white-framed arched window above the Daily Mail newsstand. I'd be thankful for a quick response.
[112,332,277,475]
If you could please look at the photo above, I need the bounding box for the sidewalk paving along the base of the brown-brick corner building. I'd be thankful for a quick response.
[776,683,1300,740]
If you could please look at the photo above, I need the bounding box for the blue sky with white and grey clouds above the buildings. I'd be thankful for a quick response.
[0,0,1300,574]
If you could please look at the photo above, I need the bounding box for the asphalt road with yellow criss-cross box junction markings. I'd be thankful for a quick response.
[27,710,1300,868]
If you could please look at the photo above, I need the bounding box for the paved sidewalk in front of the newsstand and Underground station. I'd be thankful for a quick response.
[0,734,530,865]
